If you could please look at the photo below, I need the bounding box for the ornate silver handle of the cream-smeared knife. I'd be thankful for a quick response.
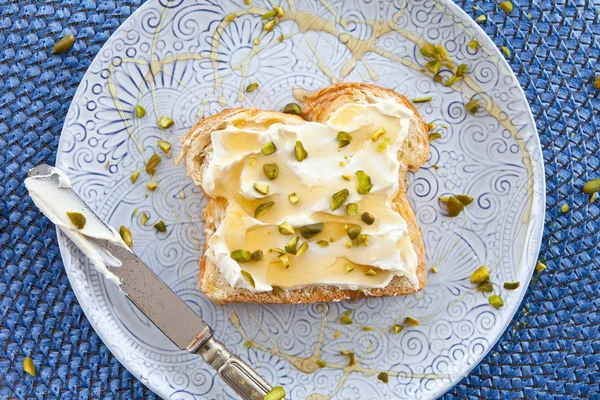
[196,337,271,400]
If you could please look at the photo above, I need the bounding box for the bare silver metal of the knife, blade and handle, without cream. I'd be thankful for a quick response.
[27,164,271,400]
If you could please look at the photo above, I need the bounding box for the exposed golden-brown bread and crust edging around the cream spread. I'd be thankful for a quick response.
[177,83,429,304]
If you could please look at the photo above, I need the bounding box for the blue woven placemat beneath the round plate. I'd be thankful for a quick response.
[0,0,600,399]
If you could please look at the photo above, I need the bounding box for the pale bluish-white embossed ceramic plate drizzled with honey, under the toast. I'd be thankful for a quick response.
[57,0,545,399]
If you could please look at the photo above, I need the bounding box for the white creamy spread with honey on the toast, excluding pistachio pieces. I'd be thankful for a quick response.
[202,99,419,292]
